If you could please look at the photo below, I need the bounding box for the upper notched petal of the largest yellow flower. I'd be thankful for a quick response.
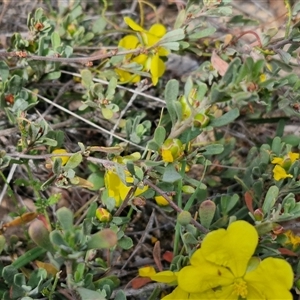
[201,221,258,277]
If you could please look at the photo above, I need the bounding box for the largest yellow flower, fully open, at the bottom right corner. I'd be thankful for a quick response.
[152,221,293,300]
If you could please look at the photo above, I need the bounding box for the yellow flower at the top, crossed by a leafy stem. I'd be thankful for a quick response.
[116,17,169,85]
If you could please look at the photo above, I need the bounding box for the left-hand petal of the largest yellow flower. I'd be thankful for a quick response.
[177,248,234,293]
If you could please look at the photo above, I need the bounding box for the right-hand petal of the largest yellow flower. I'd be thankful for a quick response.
[244,257,294,300]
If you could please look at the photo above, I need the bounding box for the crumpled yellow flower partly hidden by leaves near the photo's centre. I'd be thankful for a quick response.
[104,170,148,207]
